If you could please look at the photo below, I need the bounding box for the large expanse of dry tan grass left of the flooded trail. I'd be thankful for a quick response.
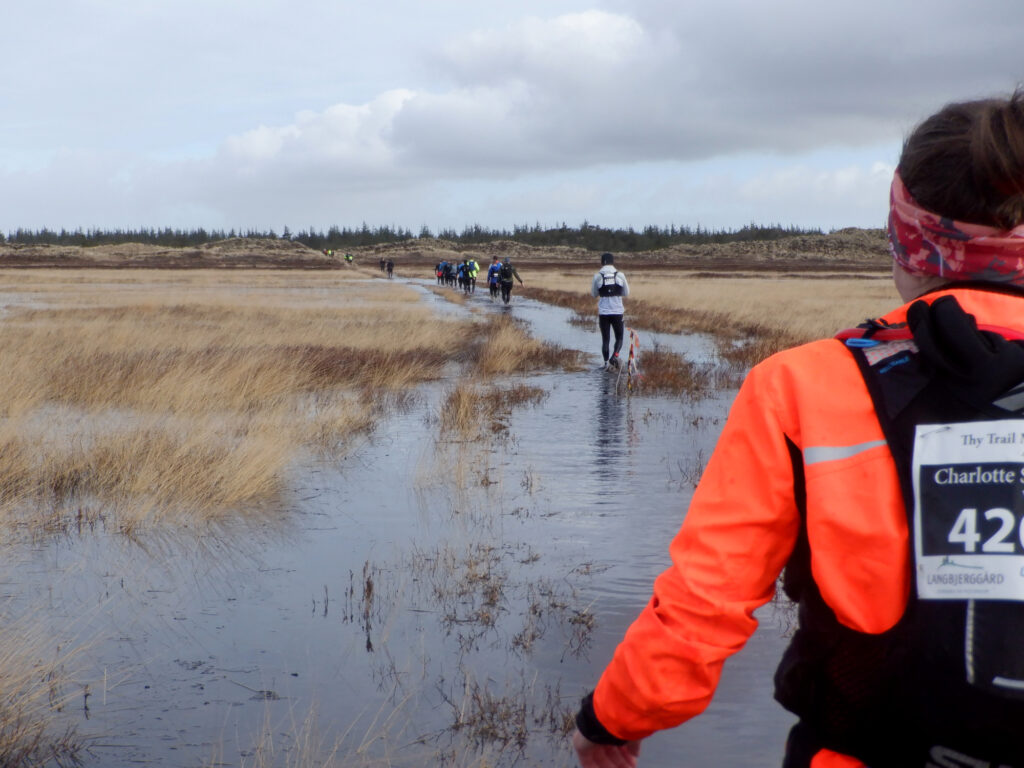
[0,271,477,531]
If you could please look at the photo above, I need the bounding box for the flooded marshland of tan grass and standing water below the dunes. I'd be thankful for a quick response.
[0,264,885,768]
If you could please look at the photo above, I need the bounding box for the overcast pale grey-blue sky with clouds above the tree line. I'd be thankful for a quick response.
[0,0,1024,232]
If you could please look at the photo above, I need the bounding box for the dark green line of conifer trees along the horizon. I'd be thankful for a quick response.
[0,221,824,253]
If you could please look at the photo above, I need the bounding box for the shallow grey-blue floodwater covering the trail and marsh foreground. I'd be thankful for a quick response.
[6,280,792,768]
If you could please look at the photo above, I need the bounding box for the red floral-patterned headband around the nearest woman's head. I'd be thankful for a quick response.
[889,171,1024,286]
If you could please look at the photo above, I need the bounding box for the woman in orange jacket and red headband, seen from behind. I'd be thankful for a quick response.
[572,91,1024,768]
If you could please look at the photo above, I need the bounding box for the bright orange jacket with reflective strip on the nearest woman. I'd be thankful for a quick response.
[593,287,1024,768]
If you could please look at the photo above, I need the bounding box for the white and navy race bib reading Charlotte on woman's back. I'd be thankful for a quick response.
[913,419,1024,601]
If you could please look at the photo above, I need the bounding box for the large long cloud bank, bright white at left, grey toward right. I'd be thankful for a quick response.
[190,0,1012,188]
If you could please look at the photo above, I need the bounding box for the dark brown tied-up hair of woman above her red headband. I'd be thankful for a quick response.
[899,88,1024,229]
